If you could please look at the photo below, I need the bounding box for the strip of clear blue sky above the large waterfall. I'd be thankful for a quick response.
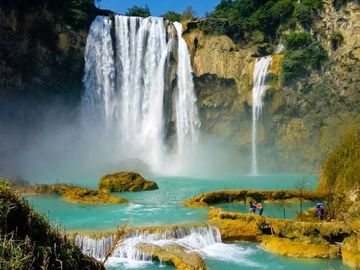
[98,0,220,16]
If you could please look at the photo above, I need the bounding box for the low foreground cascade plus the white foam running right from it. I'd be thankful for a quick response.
[75,226,258,269]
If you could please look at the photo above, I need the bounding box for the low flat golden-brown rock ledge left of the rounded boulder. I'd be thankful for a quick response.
[28,184,128,204]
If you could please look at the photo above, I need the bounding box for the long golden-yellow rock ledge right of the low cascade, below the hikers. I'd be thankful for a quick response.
[209,208,353,258]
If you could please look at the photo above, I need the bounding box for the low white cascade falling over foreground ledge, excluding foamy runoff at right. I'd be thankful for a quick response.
[75,226,221,263]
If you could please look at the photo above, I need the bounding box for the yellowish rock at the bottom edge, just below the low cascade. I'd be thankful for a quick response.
[137,244,206,270]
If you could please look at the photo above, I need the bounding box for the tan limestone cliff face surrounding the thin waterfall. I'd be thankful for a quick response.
[185,0,360,172]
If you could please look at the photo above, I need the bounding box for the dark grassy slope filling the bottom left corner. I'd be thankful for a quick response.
[0,180,105,270]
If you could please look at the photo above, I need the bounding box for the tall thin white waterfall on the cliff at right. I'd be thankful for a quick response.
[251,55,272,175]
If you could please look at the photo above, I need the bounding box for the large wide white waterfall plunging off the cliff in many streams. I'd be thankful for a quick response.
[82,15,200,171]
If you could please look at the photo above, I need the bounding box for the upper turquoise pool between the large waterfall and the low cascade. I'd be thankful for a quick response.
[27,175,317,230]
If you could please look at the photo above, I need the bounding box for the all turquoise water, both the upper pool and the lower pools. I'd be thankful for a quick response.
[24,175,348,270]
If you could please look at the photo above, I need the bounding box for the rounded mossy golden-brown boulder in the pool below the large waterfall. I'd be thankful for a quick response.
[99,172,159,192]
